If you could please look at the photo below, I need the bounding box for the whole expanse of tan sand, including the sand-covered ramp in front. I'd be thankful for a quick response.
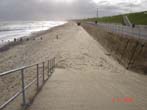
[0,22,147,110]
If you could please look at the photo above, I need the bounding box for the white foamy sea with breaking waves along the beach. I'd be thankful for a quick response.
[0,21,66,45]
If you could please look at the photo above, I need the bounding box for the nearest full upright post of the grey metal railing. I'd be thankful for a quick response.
[21,69,26,107]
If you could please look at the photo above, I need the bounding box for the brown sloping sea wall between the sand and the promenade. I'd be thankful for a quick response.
[82,23,147,74]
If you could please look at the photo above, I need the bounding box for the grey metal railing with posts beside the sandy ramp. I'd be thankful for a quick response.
[0,58,55,110]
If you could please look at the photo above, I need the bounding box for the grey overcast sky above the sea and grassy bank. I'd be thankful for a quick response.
[0,0,147,20]
